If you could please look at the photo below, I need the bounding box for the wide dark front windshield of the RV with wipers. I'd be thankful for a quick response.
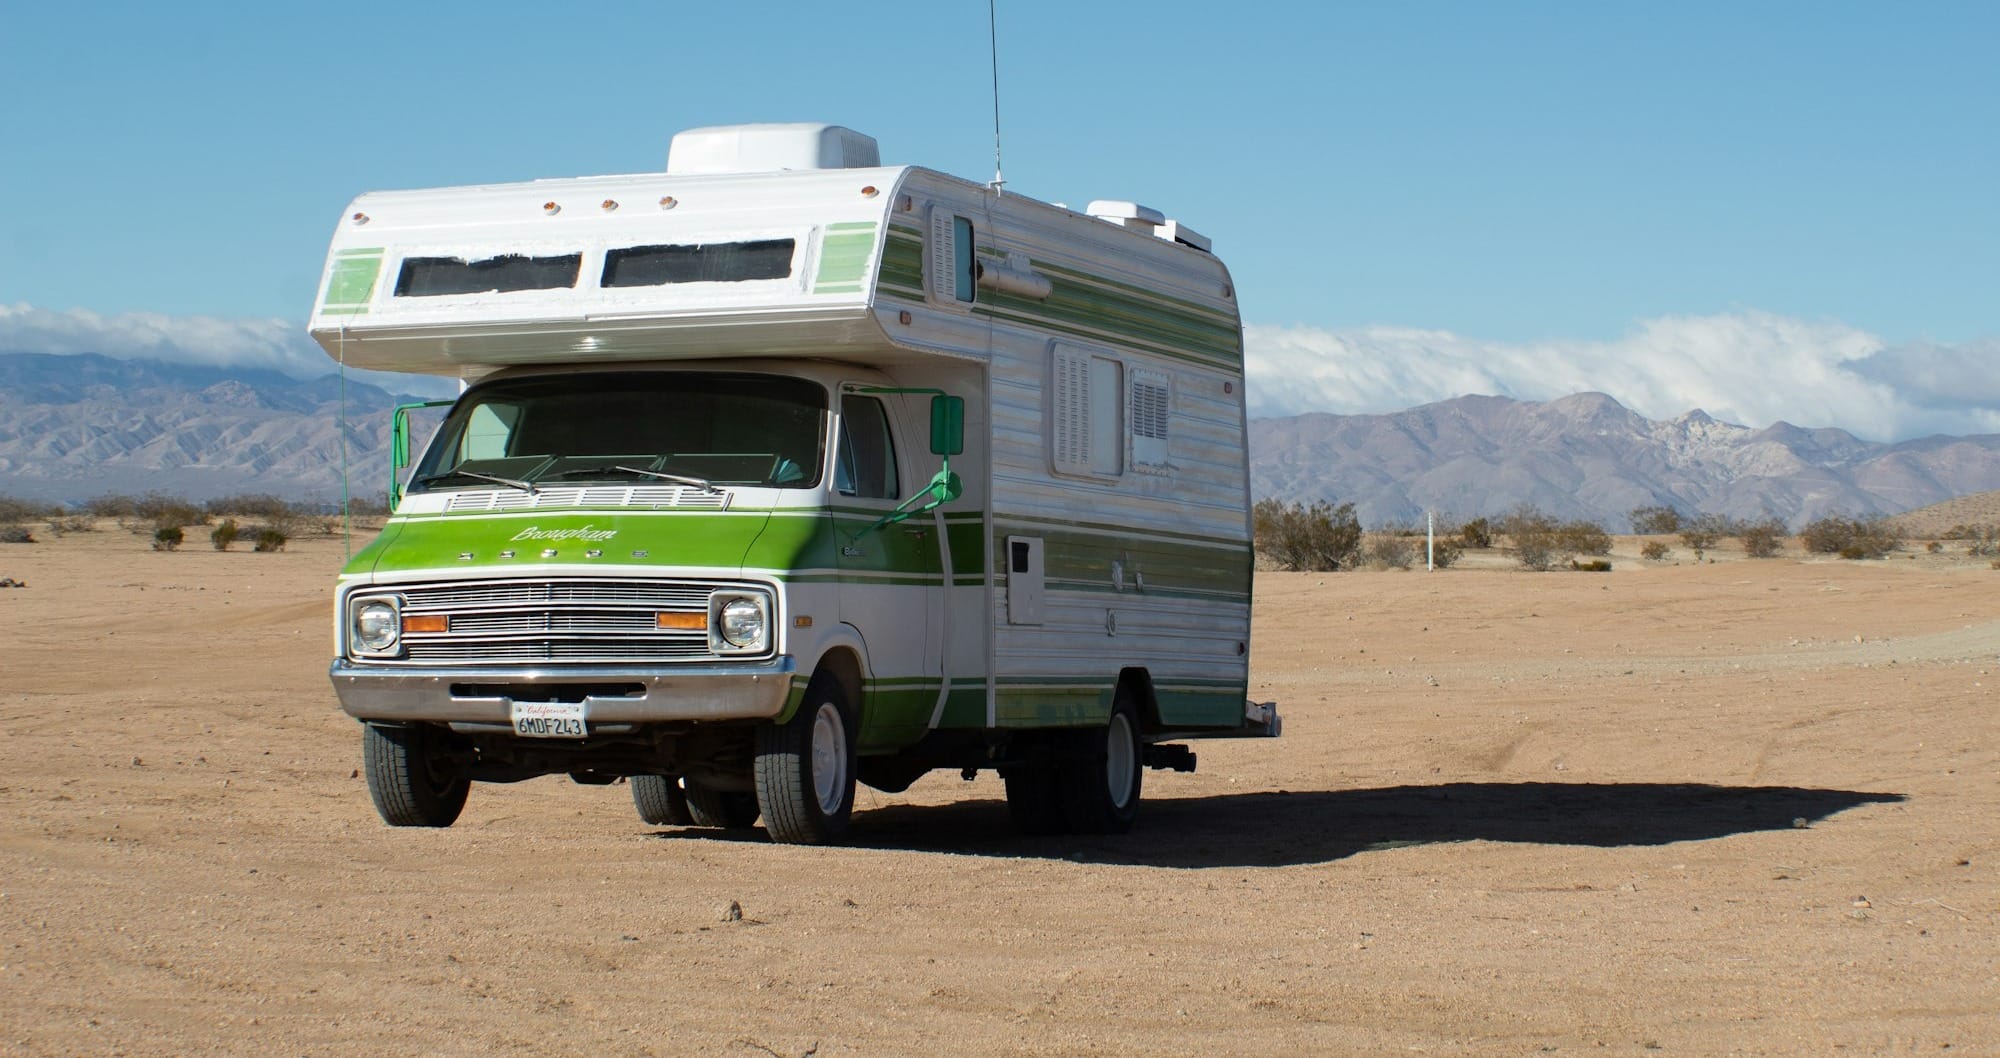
[410,372,826,492]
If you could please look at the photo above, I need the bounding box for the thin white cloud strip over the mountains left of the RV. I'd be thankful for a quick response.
[0,304,458,394]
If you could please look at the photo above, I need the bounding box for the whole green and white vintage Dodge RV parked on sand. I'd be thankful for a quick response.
[312,124,1278,842]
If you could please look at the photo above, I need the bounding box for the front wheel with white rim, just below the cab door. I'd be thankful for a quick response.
[756,672,854,844]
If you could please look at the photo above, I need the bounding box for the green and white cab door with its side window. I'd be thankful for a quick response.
[832,392,944,752]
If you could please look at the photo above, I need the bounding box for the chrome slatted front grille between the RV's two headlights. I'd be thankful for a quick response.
[388,578,754,666]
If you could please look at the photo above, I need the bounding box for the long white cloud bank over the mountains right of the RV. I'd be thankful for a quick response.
[1244,312,2000,440]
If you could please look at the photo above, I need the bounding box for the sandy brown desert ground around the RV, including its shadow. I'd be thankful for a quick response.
[0,530,2000,1058]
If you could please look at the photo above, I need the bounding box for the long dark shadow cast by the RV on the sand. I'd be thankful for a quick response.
[662,782,1906,868]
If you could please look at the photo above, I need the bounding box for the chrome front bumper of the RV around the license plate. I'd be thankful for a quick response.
[328,656,798,726]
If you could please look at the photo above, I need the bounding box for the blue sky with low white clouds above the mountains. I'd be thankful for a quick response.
[0,0,2000,436]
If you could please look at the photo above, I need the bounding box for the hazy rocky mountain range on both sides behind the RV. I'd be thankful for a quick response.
[0,352,2000,530]
